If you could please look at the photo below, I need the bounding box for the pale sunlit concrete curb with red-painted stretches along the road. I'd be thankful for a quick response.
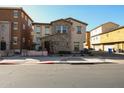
[0,59,124,65]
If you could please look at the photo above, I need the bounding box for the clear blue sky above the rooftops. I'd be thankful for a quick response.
[1,5,124,31]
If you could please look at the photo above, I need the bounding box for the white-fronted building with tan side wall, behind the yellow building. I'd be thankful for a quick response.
[90,22,119,51]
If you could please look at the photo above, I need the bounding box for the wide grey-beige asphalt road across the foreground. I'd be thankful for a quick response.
[0,64,124,88]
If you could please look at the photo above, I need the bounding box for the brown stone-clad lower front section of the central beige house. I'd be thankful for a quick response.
[41,33,71,53]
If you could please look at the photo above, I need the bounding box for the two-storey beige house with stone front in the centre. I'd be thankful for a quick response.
[33,18,87,53]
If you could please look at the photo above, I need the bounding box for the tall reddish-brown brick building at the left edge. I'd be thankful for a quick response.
[0,7,33,53]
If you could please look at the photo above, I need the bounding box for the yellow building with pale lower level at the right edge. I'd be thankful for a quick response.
[99,26,124,52]
